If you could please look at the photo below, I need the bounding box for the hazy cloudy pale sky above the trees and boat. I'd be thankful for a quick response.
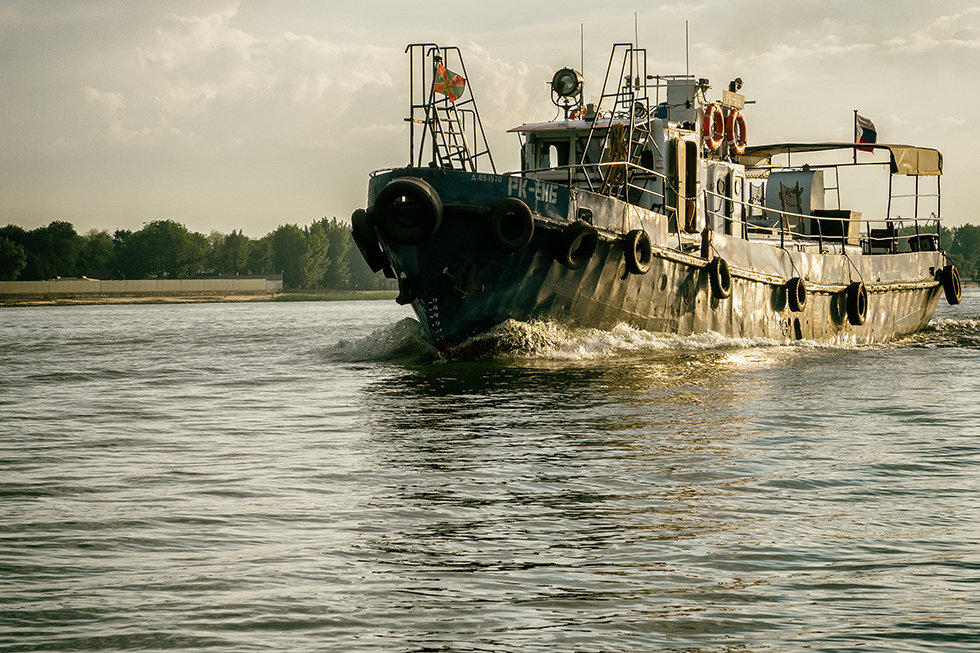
[0,0,980,237]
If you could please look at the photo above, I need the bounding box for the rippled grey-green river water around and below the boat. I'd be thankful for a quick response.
[0,288,980,651]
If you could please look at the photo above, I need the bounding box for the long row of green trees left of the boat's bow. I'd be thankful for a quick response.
[0,218,392,290]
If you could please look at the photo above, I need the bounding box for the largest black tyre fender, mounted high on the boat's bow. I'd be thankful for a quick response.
[374,177,442,245]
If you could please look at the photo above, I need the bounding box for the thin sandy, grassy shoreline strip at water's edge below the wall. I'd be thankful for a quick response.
[0,290,398,308]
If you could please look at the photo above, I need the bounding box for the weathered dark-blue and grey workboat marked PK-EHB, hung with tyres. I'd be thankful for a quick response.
[351,43,961,353]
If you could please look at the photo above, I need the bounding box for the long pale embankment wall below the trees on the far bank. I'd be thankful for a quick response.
[0,279,282,296]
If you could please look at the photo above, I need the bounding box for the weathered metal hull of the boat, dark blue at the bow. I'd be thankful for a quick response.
[360,168,943,351]
